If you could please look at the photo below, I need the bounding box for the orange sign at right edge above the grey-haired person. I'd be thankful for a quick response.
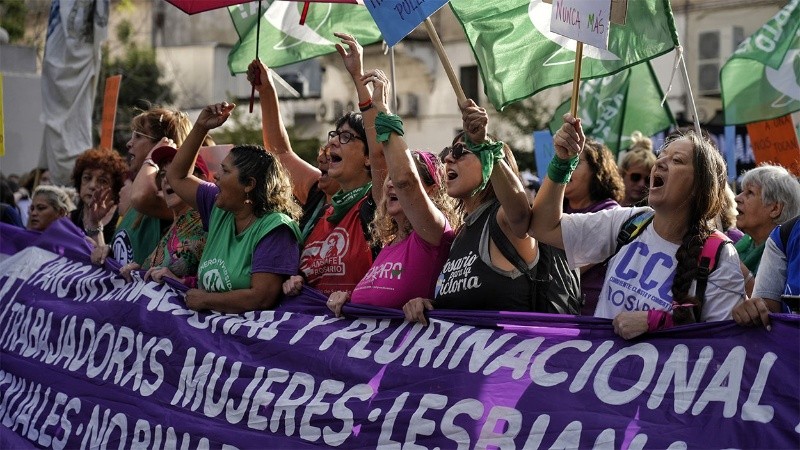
[747,115,800,176]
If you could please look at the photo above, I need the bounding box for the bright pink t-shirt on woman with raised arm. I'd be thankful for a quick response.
[350,223,455,309]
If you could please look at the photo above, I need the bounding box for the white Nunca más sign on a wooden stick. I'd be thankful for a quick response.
[550,0,611,50]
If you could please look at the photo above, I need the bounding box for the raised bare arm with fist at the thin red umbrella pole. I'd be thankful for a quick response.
[247,59,320,204]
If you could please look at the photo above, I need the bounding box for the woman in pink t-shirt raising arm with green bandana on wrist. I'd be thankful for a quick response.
[328,70,460,316]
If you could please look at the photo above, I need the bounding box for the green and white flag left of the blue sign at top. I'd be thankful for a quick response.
[228,1,381,74]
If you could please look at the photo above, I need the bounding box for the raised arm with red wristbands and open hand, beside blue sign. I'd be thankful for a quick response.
[334,33,387,204]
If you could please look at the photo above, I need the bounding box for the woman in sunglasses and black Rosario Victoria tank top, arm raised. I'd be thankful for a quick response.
[403,96,552,323]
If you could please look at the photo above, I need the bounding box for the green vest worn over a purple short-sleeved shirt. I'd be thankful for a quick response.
[197,206,300,292]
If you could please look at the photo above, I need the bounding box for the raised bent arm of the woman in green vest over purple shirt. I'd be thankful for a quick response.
[167,102,236,209]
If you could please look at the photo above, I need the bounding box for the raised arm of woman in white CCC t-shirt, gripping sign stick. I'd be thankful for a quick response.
[530,114,586,249]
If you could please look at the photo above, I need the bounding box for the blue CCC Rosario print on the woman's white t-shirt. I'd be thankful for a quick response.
[607,241,675,311]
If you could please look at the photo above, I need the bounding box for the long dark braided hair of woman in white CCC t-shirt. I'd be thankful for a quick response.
[666,131,726,325]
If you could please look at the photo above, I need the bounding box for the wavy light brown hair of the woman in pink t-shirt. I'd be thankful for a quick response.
[369,150,462,247]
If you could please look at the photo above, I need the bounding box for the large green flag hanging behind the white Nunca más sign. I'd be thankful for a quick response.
[450,0,678,109]
